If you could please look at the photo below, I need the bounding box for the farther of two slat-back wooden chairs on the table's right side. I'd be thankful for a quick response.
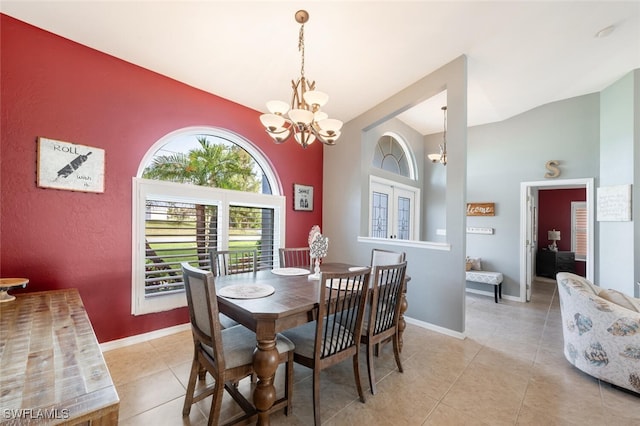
[360,261,407,394]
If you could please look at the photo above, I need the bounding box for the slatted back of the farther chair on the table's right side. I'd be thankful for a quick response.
[368,261,407,336]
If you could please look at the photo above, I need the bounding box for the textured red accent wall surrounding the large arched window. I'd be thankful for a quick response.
[0,14,323,342]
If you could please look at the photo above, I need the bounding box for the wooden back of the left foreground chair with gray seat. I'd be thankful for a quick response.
[182,262,225,370]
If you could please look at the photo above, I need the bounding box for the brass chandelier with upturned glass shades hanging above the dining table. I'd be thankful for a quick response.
[260,10,342,148]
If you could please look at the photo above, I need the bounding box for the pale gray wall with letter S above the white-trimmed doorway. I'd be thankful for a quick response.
[467,93,600,297]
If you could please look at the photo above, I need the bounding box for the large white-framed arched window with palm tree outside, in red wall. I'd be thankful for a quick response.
[132,127,285,315]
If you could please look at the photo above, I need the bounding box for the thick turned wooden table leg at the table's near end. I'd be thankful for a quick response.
[253,335,279,426]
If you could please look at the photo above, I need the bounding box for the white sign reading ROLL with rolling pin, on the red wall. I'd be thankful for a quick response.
[37,138,104,192]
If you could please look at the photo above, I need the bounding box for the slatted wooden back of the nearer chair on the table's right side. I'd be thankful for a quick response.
[315,268,371,359]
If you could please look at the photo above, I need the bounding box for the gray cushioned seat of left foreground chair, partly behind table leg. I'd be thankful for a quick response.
[203,325,295,368]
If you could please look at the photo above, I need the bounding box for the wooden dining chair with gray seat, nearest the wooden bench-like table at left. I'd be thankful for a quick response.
[182,262,294,425]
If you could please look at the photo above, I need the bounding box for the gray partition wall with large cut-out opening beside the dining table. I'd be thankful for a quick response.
[322,56,467,333]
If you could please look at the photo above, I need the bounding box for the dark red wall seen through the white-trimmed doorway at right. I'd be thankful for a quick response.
[538,188,587,276]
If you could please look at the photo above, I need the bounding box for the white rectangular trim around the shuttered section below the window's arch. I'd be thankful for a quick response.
[131,177,286,315]
